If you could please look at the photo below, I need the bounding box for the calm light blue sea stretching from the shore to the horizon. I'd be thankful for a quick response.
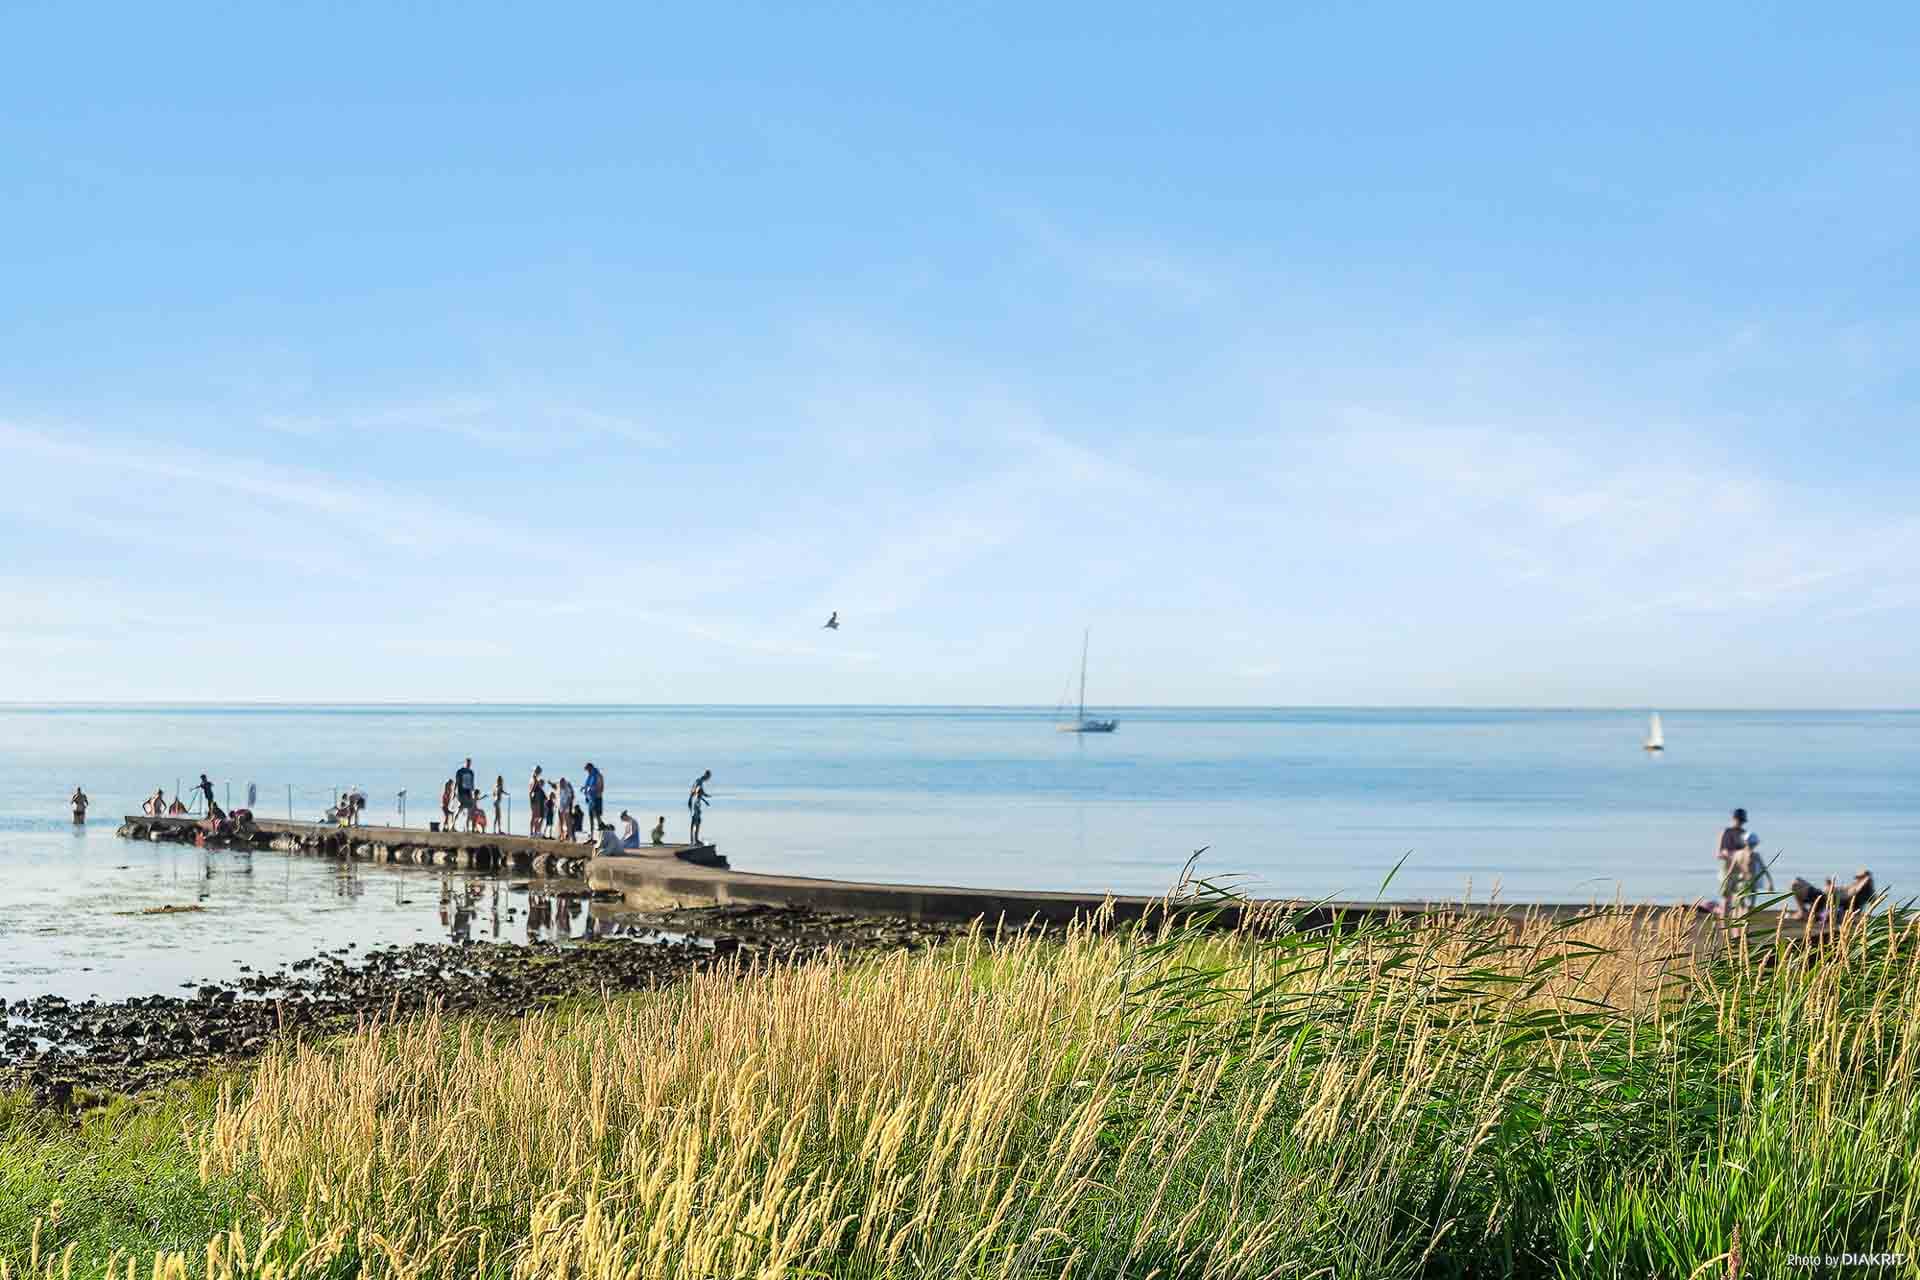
[0,704,1920,1002]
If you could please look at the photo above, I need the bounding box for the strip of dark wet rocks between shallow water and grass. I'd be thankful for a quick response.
[0,906,958,1109]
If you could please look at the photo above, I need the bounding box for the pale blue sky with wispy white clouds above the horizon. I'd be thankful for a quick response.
[0,4,1920,706]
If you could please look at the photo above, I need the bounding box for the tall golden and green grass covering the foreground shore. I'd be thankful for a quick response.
[0,912,1920,1278]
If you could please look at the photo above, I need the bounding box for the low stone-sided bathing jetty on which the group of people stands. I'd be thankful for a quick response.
[119,814,726,879]
